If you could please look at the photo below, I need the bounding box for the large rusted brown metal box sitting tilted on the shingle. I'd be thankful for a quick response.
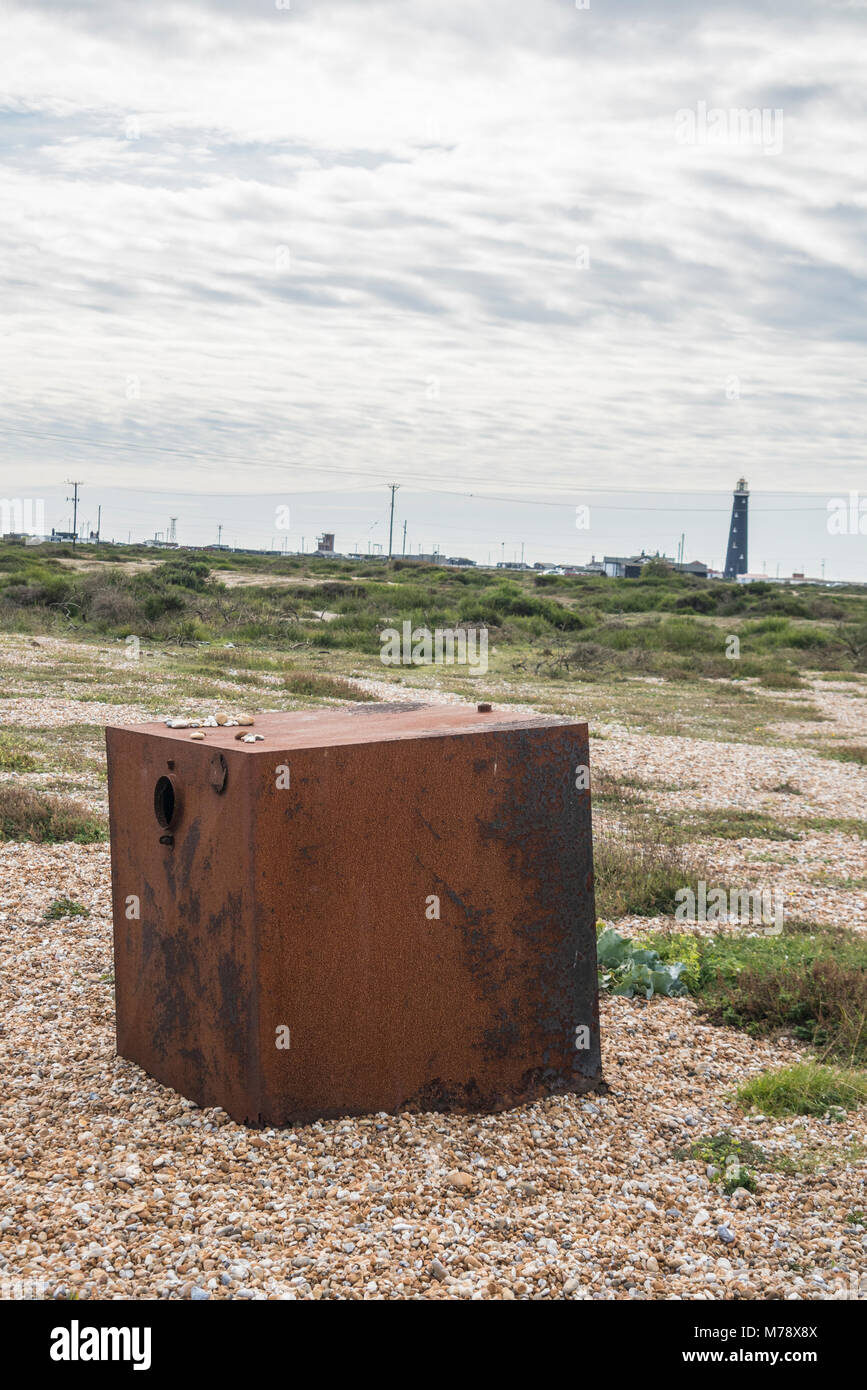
[107,705,602,1126]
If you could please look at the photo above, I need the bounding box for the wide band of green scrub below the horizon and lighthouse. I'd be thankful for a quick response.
[0,543,867,683]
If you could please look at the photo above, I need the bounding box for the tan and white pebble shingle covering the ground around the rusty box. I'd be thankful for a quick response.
[0,644,867,1300]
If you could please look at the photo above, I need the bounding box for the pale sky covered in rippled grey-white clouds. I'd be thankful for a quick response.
[0,0,867,578]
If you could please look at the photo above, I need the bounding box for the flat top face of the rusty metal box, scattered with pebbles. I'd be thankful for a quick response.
[108,703,586,753]
